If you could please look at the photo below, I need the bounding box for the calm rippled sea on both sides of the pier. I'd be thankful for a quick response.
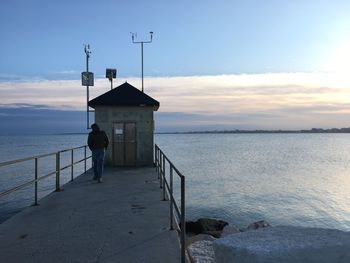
[0,134,350,231]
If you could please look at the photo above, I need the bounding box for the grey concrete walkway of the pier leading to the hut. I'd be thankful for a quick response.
[0,167,180,263]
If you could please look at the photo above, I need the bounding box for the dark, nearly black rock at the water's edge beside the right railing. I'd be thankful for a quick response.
[186,218,228,238]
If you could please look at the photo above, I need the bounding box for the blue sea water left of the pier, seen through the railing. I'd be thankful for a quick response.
[0,134,91,223]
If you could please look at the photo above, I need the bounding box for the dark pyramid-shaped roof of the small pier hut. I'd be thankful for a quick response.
[89,82,159,110]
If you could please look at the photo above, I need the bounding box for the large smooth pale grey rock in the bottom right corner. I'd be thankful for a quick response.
[213,226,350,263]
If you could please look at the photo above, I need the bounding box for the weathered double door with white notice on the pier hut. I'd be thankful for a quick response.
[113,122,137,166]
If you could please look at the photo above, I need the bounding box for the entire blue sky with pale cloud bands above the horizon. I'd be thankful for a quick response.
[0,0,350,135]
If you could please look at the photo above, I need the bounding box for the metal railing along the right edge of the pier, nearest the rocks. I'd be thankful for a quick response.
[154,144,186,263]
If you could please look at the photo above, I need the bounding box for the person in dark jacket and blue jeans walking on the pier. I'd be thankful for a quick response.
[88,123,109,183]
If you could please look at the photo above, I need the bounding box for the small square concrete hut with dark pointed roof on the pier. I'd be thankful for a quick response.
[89,82,159,166]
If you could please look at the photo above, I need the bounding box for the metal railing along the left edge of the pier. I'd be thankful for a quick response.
[0,145,91,205]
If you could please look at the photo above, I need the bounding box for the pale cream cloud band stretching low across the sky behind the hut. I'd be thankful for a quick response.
[0,72,350,129]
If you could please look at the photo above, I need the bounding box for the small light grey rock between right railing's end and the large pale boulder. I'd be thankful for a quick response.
[187,240,215,263]
